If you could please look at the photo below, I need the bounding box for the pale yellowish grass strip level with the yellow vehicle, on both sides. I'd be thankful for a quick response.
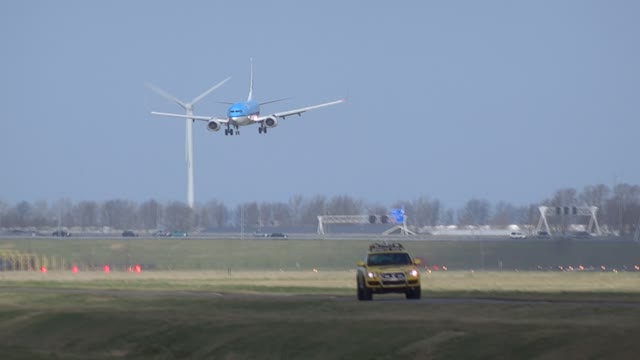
[0,270,640,301]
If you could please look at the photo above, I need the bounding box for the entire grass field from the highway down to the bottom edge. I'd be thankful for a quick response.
[0,239,640,359]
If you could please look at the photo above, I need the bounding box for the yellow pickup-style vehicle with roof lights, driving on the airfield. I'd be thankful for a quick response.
[357,243,422,300]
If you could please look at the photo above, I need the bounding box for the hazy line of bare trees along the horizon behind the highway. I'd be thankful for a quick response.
[0,184,640,234]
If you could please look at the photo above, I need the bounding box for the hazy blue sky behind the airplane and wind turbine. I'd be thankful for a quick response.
[0,0,640,207]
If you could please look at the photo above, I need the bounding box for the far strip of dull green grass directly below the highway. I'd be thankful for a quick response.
[0,238,640,270]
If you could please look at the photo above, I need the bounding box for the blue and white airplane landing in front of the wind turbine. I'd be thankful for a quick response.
[151,62,346,135]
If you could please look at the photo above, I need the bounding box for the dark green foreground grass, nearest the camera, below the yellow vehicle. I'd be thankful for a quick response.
[0,291,640,359]
